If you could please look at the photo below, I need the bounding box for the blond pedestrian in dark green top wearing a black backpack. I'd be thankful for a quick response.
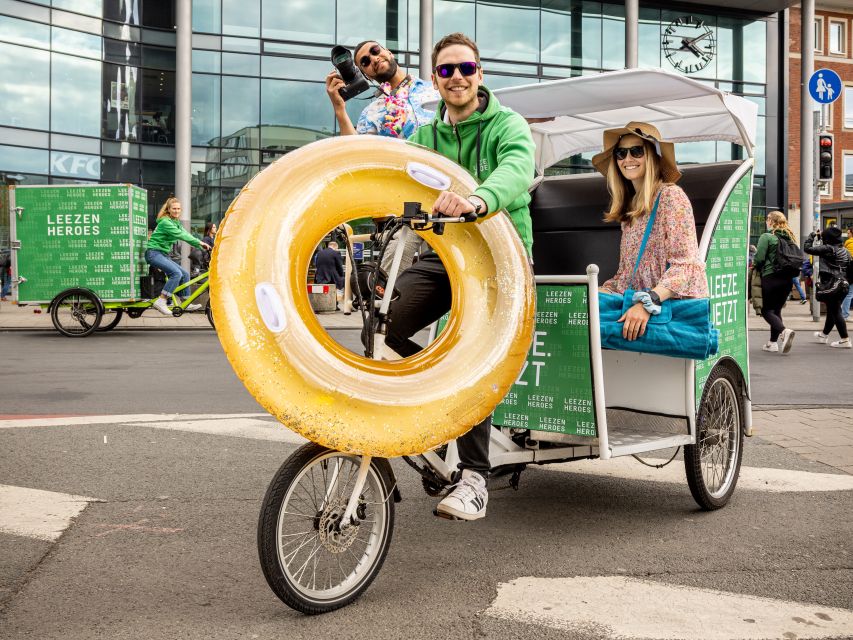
[753,211,805,354]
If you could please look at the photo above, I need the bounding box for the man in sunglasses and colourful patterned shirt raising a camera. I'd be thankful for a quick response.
[326,40,438,139]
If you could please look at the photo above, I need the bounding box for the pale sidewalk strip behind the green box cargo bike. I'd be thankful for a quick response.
[0,302,362,335]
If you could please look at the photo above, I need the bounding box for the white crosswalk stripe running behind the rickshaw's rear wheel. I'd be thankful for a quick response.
[542,458,853,493]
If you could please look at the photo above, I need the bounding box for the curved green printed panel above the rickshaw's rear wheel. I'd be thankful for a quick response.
[696,172,752,407]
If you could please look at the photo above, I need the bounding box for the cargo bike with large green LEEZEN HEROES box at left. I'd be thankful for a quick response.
[9,185,213,338]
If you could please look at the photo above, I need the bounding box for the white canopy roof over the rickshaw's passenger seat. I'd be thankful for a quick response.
[486,69,758,173]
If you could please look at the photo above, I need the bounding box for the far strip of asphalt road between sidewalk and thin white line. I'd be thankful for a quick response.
[0,329,853,414]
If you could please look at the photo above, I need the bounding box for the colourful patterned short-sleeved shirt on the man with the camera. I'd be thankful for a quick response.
[355,76,440,139]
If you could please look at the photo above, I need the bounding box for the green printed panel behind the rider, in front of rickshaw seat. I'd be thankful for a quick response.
[492,284,597,436]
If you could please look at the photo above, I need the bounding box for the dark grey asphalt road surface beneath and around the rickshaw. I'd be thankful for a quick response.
[0,331,853,640]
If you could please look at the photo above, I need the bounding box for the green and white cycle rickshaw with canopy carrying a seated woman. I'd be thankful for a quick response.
[221,70,757,614]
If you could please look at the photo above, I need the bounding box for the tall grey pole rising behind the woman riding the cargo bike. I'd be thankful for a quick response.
[175,0,193,271]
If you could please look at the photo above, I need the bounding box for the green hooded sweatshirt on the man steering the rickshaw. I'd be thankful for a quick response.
[409,86,536,255]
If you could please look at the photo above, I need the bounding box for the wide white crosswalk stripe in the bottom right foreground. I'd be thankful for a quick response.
[486,576,853,640]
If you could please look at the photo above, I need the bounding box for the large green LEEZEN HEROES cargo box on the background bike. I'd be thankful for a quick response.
[10,185,148,303]
